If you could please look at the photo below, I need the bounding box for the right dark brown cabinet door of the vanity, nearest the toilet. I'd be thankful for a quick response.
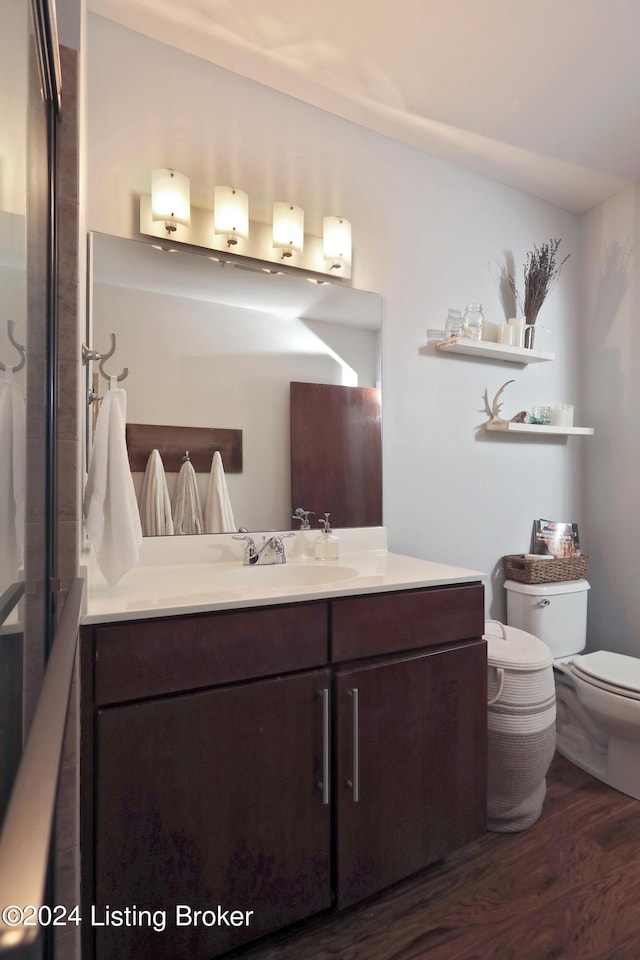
[336,641,487,907]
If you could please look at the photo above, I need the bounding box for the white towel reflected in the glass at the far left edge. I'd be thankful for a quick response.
[0,370,25,593]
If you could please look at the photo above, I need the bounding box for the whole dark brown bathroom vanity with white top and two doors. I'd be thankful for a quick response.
[81,532,486,960]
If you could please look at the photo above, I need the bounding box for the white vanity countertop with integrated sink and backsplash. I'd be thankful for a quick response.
[82,527,486,623]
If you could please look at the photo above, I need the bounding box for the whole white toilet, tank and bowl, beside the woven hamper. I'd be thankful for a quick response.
[504,579,640,800]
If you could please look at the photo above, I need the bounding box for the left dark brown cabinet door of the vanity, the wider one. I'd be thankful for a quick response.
[93,670,330,960]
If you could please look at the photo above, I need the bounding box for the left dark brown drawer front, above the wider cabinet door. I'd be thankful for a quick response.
[95,603,328,705]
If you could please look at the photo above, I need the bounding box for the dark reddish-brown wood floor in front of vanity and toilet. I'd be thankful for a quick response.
[228,755,640,960]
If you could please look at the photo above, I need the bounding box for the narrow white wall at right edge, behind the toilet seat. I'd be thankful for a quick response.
[580,184,640,656]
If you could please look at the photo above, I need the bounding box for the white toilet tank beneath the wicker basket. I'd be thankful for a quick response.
[504,580,590,660]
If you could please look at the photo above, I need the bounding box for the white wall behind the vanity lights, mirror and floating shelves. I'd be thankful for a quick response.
[87,16,590,616]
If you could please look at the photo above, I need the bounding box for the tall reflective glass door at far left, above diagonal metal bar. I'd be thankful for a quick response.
[0,0,59,821]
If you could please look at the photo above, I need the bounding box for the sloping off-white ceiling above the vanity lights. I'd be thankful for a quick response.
[88,0,640,213]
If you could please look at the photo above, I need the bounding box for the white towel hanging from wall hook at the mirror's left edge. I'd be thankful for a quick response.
[84,378,142,586]
